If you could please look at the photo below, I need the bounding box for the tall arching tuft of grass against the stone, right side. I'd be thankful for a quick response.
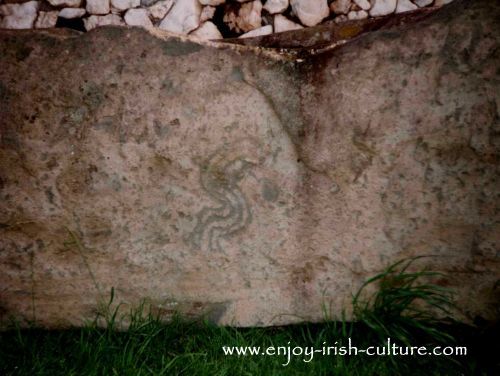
[353,257,454,345]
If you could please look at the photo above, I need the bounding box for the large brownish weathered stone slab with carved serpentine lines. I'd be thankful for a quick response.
[0,0,500,327]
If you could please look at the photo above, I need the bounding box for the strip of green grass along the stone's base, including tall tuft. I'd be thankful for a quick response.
[0,260,500,376]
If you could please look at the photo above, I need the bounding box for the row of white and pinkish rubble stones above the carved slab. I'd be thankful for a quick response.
[0,0,452,39]
